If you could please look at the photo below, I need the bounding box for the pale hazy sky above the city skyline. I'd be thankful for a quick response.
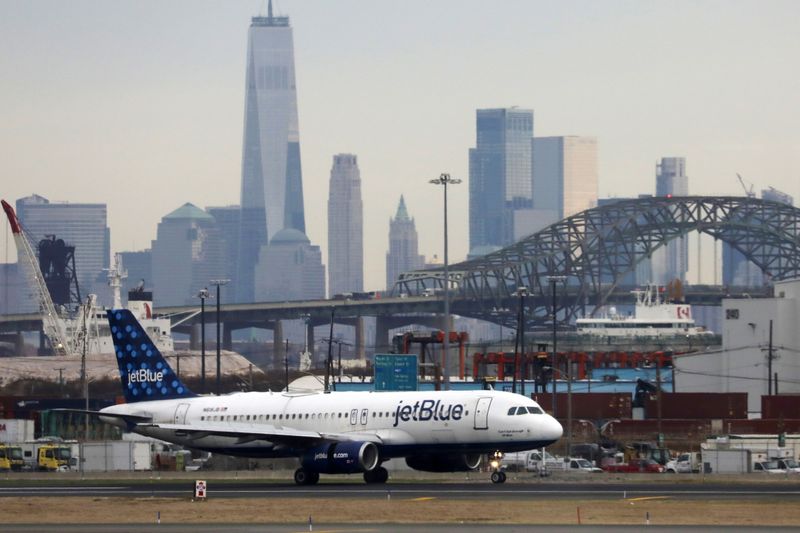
[0,0,800,289]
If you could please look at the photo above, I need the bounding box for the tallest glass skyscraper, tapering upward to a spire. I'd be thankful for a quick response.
[235,1,306,301]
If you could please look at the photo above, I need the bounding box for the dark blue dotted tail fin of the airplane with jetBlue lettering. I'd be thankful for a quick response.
[107,309,197,403]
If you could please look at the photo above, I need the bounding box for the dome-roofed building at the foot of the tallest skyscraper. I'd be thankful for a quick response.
[255,229,325,302]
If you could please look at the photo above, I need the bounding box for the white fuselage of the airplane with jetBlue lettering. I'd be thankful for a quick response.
[101,390,562,458]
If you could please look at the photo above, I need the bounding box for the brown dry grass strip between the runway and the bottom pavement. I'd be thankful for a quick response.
[2,497,800,527]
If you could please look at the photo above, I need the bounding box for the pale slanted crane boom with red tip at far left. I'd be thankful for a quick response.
[0,200,73,355]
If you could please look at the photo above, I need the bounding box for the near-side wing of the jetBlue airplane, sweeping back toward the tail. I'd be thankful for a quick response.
[137,423,383,446]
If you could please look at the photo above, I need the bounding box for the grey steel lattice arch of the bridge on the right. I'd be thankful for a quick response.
[394,196,800,326]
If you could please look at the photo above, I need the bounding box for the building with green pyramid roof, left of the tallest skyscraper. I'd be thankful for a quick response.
[152,203,224,306]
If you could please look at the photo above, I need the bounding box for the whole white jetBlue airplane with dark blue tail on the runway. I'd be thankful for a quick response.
[84,309,562,485]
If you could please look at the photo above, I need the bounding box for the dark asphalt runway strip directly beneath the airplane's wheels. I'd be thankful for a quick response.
[0,479,800,501]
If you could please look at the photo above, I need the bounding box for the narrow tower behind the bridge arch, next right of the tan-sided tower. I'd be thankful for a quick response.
[652,157,689,285]
